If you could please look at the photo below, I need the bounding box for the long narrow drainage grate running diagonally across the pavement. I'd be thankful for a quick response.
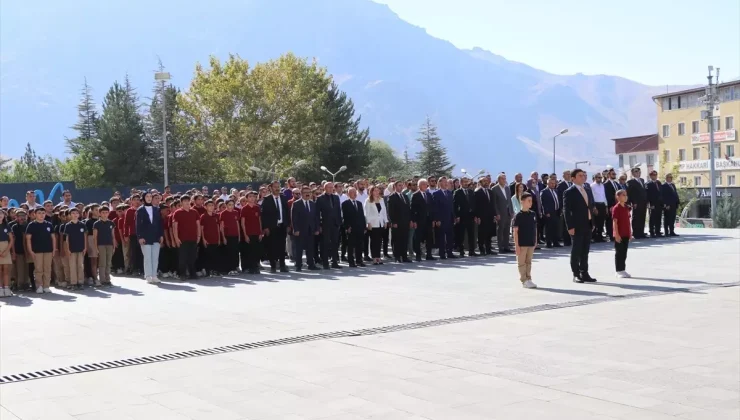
[0,282,740,385]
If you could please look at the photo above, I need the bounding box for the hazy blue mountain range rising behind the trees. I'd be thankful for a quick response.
[0,0,684,173]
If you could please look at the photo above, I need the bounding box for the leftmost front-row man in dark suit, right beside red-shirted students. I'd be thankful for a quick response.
[262,181,290,273]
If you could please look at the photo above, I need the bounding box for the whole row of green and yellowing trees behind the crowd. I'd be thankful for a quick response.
[0,54,454,187]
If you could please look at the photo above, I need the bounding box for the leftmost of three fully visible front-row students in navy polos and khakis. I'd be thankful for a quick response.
[25,207,57,293]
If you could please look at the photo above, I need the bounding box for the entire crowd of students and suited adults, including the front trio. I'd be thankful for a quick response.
[0,168,679,297]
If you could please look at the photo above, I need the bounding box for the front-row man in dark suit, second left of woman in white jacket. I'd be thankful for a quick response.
[316,182,342,270]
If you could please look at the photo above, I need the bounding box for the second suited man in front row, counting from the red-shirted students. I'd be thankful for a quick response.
[291,186,319,271]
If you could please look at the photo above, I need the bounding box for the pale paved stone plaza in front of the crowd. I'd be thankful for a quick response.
[0,230,740,420]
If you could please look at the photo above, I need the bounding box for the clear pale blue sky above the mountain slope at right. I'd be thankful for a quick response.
[375,0,740,86]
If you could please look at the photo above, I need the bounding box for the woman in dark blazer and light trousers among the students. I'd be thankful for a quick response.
[136,192,164,284]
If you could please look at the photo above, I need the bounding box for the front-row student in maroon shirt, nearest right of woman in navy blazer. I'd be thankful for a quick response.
[172,195,200,279]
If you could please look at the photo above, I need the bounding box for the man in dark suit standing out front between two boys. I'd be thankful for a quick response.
[563,168,596,283]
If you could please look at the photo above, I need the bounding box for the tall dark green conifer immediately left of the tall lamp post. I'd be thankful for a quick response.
[98,81,150,186]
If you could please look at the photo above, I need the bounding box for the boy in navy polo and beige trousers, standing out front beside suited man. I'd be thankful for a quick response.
[513,192,537,289]
